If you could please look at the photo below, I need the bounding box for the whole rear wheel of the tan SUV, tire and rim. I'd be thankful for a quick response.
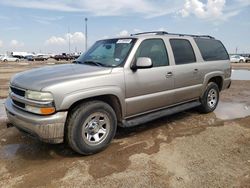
[199,82,220,113]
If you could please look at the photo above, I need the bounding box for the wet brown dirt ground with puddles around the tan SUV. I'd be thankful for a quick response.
[0,62,250,188]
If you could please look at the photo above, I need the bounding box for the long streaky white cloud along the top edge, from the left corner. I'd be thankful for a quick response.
[0,0,183,18]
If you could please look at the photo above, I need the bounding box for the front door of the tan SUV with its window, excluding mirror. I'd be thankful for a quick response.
[125,38,174,116]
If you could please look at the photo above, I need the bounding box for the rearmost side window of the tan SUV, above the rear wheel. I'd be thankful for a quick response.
[194,38,229,61]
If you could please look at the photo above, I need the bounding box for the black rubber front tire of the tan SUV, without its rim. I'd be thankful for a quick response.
[69,102,117,155]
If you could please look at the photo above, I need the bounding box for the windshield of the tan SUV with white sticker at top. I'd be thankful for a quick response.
[75,38,136,67]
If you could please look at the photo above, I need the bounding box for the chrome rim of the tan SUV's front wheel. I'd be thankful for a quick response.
[82,112,110,145]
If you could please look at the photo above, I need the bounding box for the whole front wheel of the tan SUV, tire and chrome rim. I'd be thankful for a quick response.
[65,101,117,155]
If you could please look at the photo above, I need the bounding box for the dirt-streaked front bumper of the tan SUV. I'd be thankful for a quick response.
[5,98,67,143]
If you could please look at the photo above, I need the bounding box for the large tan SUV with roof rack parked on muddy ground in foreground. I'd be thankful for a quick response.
[5,31,231,155]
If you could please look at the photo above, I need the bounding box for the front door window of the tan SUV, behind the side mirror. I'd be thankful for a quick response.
[135,39,169,67]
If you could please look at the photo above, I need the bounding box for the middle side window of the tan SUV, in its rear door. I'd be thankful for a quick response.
[170,39,196,65]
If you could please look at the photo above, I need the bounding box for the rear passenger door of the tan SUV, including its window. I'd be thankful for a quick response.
[169,38,203,103]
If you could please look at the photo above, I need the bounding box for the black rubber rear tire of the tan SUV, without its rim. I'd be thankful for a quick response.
[200,82,220,113]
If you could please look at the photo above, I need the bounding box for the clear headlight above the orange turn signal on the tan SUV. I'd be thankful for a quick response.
[25,90,53,101]
